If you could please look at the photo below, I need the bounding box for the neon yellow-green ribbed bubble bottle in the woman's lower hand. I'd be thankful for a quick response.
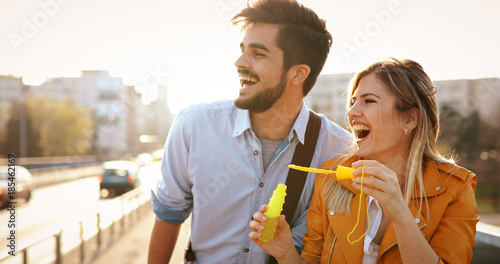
[259,183,286,242]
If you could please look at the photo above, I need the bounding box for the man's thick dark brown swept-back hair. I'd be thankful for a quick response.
[230,0,332,96]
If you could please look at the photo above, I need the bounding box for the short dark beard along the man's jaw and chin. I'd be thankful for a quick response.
[234,73,286,113]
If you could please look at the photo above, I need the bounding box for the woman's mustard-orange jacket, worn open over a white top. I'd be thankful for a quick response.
[302,159,479,264]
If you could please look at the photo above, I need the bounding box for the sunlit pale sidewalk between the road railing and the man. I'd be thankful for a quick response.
[92,210,191,264]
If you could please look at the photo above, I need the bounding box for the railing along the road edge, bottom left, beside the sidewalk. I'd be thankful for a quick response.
[0,187,151,264]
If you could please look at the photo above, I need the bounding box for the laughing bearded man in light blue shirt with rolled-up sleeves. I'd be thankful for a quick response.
[148,0,350,263]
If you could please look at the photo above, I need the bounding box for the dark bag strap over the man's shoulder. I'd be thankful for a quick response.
[267,110,321,264]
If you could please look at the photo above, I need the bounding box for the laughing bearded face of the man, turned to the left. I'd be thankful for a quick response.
[234,23,287,113]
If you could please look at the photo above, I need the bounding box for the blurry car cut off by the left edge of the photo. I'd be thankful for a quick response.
[0,165,35,207]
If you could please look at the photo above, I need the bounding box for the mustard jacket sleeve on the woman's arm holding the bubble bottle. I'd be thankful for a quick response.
[301,175,328,263]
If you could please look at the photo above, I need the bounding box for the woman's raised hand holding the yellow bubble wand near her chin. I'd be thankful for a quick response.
[352,160,412,222]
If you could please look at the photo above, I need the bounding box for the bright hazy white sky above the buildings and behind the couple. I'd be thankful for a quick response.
[0,0,500,113]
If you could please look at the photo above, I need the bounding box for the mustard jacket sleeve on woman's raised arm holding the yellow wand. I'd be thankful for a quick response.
[430,172,479,263]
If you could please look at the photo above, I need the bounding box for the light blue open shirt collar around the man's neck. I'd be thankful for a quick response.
[233,102,309,144]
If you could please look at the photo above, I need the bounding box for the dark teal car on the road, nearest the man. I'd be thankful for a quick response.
[98,160,141,197]
